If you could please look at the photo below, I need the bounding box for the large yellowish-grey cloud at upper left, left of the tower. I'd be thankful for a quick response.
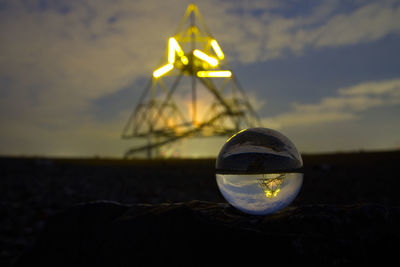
[0,1,194,134]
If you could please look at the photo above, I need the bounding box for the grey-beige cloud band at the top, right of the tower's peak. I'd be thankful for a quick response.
[218,1,400,63]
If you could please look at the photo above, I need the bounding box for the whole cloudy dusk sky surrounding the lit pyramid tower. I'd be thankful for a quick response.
[0,0,400,157]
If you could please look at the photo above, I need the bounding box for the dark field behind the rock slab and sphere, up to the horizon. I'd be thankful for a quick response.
[0,151,400,266]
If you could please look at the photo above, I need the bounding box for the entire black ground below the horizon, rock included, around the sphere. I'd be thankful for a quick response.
[0,151,400,266]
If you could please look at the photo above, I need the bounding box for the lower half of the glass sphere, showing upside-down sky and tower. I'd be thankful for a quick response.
[217,173,303,215]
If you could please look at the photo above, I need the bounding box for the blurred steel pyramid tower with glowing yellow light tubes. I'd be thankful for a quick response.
[122,4,259,158]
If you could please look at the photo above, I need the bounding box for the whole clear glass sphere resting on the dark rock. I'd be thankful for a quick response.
[216,128,303,215]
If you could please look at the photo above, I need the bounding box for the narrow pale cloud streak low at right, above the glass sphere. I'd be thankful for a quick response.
[263,79,400,128]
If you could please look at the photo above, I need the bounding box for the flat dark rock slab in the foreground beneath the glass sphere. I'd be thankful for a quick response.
[16,201,400,267]
